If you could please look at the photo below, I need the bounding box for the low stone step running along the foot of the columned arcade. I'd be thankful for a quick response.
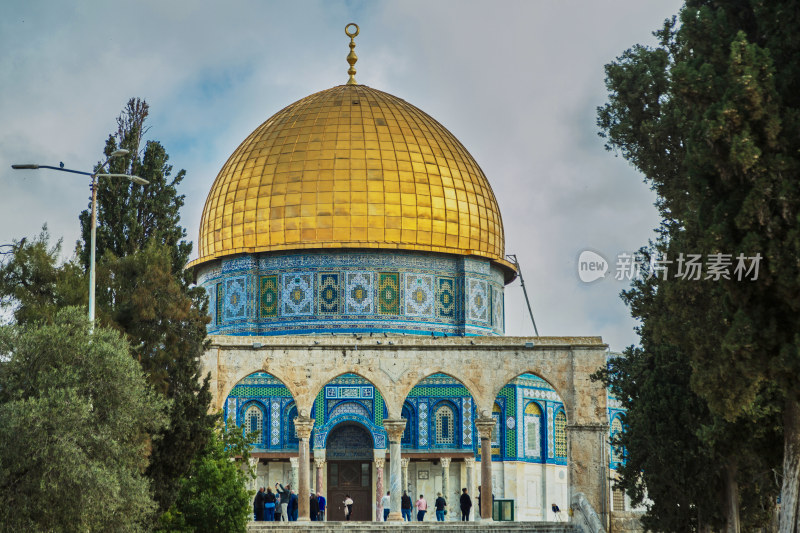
[247,522,580,533]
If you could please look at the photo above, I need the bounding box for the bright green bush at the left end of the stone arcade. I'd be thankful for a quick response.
[159,425,253,533]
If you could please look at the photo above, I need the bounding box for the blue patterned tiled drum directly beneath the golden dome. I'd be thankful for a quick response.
[197,250,504,336]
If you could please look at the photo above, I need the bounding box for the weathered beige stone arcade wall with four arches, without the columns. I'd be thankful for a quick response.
[203,335,608,513]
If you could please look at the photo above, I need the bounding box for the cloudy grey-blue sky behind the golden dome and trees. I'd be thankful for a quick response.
[0,0,681,350]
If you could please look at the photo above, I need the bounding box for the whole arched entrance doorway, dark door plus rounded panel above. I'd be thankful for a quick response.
[325,422,375,521]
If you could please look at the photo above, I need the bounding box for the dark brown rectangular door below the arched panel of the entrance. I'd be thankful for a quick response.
[326,461,373,521]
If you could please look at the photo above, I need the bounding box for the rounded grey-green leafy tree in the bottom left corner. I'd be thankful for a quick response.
[0,308,166,532]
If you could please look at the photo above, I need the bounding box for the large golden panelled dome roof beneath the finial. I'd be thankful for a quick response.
[190,85,513,271]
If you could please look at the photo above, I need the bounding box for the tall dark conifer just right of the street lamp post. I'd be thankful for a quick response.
[78,99,214,512]
